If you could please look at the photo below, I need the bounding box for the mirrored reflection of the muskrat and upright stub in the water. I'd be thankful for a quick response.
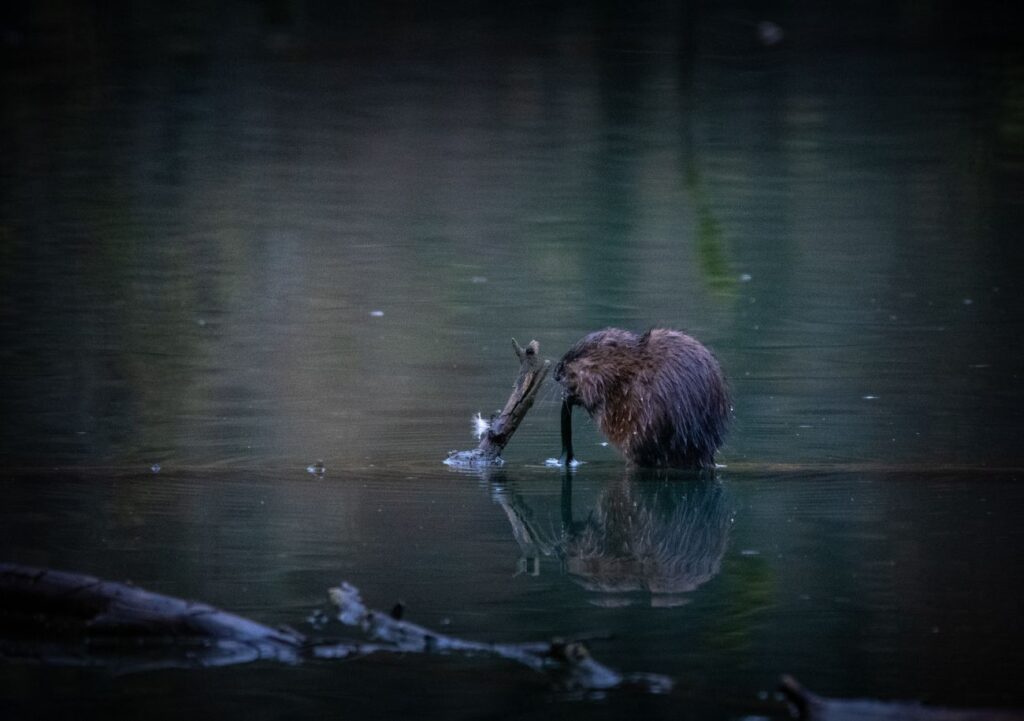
[496,472,732,605]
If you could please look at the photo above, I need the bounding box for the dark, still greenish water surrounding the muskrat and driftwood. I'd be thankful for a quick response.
[0,4,1024,719]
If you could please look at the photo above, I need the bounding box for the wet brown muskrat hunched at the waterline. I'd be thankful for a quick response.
[555,328,731,468]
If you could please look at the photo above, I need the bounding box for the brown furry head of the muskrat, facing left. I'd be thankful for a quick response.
[555,328,638,415]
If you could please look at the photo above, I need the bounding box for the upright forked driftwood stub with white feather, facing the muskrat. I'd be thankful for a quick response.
[444,338,551,466]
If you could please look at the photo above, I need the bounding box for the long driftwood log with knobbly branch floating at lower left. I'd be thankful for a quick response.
[0,563,672,693]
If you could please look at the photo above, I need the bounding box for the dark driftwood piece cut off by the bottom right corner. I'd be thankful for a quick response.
[779,676,1024,721]
